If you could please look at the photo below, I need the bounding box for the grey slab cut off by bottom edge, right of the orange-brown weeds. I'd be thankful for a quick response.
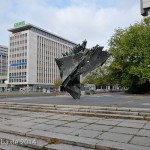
[45,144,92,150]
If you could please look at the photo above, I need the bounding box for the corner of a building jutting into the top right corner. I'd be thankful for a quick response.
[141,0,150,17]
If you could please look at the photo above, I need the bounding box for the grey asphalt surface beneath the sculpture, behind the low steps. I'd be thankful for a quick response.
[0,93,150,108]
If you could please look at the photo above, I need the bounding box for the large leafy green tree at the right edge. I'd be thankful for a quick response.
[108,18,150,93]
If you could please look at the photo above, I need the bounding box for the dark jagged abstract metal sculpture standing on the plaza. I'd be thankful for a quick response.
[55,40,110,99]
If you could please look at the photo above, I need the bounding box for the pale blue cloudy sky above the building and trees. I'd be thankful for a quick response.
[0,0,142,48]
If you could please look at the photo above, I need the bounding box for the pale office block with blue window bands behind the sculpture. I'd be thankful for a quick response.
[8,24,76,90]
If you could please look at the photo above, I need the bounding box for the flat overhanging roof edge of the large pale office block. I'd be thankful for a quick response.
[8,23,77,45]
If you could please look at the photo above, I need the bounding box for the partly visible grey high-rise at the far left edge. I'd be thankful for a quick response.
[0,45,8,91]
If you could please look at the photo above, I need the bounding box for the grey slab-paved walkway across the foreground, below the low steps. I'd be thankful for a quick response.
[0,109,150,150]
